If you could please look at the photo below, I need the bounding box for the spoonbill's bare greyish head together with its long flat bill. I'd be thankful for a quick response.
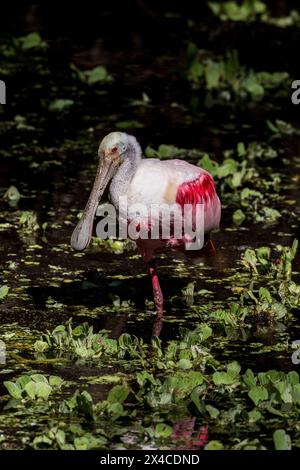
[71,132,141,251]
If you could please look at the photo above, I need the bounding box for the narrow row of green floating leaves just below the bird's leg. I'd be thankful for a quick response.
[34,321,212,369]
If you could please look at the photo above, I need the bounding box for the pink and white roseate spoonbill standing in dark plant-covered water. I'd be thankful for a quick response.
[71,132,221,333]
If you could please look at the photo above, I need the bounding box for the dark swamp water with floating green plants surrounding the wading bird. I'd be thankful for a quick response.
[0,0,300,450]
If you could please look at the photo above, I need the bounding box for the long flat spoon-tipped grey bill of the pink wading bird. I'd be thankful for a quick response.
[71,163,114,251]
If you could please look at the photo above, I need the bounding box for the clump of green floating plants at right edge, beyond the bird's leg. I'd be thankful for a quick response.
[211,240,300,327]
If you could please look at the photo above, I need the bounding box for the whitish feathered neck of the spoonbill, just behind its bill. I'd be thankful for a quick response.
[109,138,142,208]
